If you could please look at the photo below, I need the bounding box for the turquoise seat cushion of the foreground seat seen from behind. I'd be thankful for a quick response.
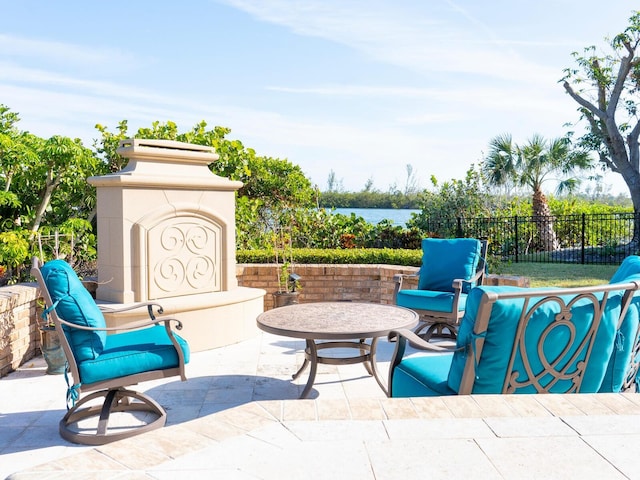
[391,353,456,397]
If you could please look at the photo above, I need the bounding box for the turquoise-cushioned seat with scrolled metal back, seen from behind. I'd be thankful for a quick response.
[388,274,640,397]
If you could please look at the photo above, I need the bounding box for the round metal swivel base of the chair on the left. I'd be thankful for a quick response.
[59,388,167,445]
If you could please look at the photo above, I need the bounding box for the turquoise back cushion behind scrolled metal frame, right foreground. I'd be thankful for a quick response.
[448,286,622,393]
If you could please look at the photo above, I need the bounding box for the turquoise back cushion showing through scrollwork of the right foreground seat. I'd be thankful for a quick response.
[448,286,621,394]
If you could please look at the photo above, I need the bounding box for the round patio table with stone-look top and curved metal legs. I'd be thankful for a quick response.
[257,302,418,398]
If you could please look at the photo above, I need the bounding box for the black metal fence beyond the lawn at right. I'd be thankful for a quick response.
[420,212,640,265]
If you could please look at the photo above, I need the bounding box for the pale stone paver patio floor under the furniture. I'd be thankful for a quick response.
[0,333,640,480]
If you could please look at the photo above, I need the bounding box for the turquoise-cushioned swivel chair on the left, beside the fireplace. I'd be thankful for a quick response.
[31,258,189,445]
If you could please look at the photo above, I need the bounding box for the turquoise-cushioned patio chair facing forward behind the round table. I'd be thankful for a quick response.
[393,238,487,341]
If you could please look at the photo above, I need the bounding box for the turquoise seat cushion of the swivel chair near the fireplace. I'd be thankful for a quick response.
[78,325,190,384]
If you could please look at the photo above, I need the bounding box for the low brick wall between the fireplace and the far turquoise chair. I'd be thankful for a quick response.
[236,263,418,310]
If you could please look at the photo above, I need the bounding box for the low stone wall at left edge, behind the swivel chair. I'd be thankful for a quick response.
[0,284,41,377]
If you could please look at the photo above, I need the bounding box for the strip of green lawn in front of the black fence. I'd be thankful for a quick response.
[499,263,618,287]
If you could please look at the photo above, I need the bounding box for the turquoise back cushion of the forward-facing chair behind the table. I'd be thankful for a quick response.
[418,238,482,292]
